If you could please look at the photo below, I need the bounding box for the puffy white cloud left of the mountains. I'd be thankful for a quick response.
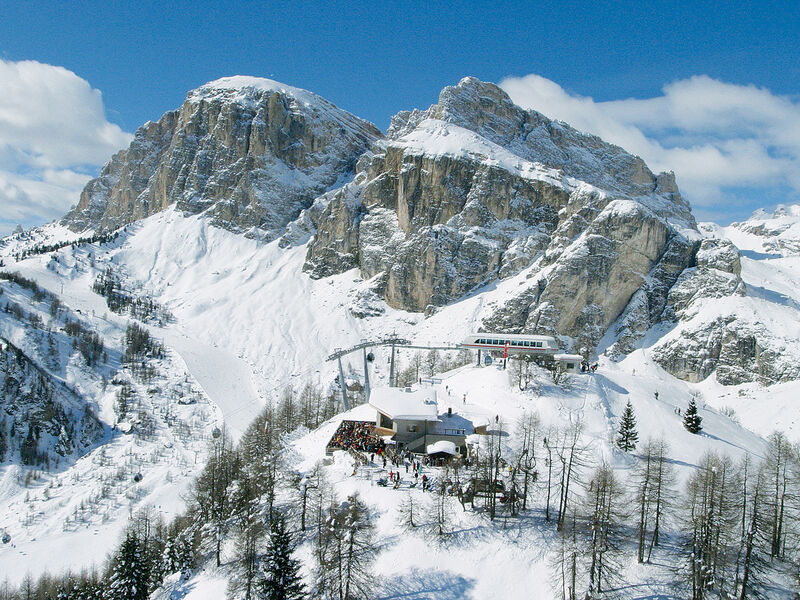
[0,59,132,235]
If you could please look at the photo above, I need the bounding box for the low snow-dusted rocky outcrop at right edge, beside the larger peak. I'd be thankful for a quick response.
[650,218,800,385]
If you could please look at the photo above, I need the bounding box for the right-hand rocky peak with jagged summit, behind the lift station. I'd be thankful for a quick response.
[305,78,699,348]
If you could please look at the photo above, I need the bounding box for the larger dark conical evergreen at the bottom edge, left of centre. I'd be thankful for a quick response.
[256,512,306,600]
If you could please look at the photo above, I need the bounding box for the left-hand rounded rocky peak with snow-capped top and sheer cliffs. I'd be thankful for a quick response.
[66,77,381,239]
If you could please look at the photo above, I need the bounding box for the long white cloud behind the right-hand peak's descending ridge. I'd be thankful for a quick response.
[500,75,800,217]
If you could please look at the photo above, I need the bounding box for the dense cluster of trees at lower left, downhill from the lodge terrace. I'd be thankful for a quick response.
[0,383,376,600]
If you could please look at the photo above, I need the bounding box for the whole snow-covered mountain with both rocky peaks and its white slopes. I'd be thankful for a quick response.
[0,77,800,597]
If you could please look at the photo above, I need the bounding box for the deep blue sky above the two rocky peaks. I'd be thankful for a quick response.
[0,1,800,234]
